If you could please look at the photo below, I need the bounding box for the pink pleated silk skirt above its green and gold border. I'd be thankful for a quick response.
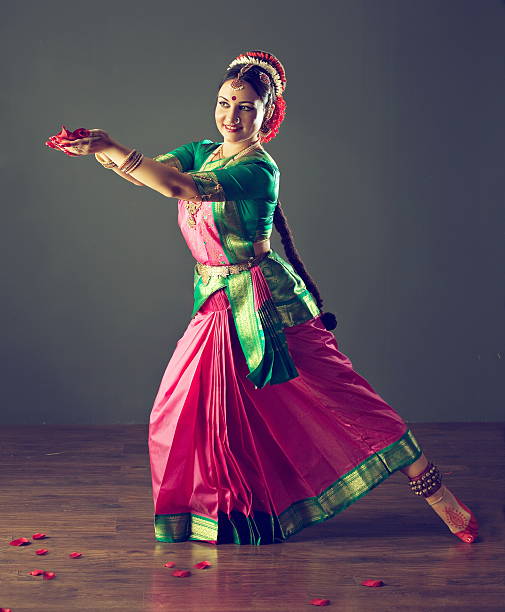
[149,290,407,532]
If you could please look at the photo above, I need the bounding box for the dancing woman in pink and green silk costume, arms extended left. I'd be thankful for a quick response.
[58,51,478,544]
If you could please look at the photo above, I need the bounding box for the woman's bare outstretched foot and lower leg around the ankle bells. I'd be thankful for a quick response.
[401,453,478,543]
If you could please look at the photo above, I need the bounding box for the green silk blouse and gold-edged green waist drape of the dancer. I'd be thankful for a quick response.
[154,140,320,387]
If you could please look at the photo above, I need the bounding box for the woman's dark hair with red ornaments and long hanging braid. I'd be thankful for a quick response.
[218,51,337,330]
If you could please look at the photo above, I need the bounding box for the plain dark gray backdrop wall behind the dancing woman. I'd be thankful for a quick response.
[0,0,505,424]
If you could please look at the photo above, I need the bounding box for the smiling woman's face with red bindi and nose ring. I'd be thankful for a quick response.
[215,79,265,143]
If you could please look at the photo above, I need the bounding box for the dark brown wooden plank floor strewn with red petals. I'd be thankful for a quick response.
[0,423,505,612]
